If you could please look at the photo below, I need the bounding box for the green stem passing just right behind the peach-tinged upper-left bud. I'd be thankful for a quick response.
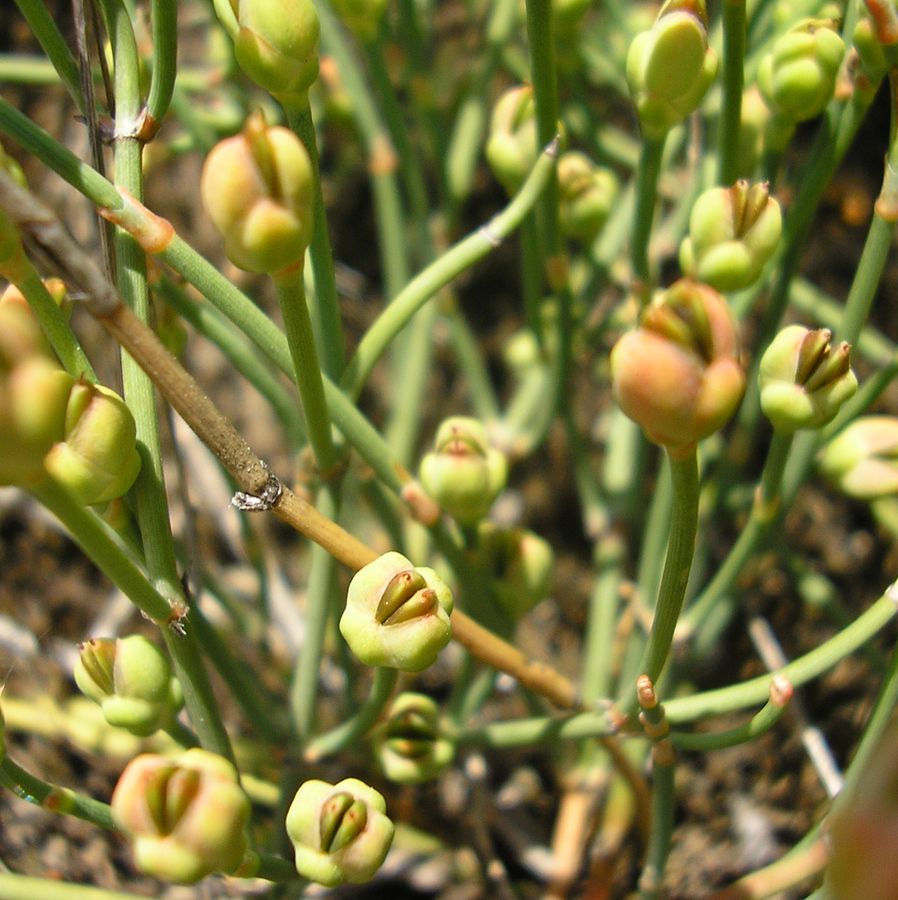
[286,104,344,378]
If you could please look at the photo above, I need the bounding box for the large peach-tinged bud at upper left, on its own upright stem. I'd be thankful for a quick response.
[200,113,313,275]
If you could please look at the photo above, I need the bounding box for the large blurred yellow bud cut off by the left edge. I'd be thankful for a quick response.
[0,356,74,485]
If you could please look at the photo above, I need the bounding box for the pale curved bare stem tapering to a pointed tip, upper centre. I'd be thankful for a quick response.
[341,142,557,397]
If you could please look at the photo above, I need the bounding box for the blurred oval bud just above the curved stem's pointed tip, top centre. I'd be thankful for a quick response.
[486,85,537,194]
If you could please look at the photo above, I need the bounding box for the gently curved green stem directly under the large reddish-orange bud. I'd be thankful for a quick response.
[622,447,699,710]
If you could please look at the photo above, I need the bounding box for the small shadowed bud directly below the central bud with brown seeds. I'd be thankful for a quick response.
[372,692,455,784]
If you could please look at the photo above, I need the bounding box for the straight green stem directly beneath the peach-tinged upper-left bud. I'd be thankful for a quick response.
[275,269,337,479]
